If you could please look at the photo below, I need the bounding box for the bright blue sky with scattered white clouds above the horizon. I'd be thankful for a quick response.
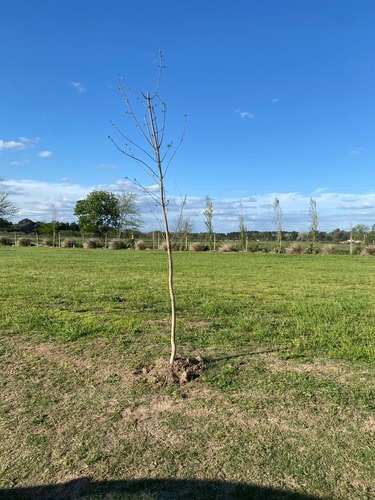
[0,0,375,231]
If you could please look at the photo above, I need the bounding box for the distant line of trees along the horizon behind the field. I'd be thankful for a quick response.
[0,191,375,242]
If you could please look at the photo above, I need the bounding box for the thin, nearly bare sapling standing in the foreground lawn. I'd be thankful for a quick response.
[109,49,186,365]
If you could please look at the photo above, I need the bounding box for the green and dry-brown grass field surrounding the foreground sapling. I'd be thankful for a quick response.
[0,247,375,500]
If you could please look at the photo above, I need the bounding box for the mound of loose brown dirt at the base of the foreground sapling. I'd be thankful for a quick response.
[142,355,204,386]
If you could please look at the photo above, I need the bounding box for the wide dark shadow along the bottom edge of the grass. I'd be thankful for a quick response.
[0,477,328,500]
